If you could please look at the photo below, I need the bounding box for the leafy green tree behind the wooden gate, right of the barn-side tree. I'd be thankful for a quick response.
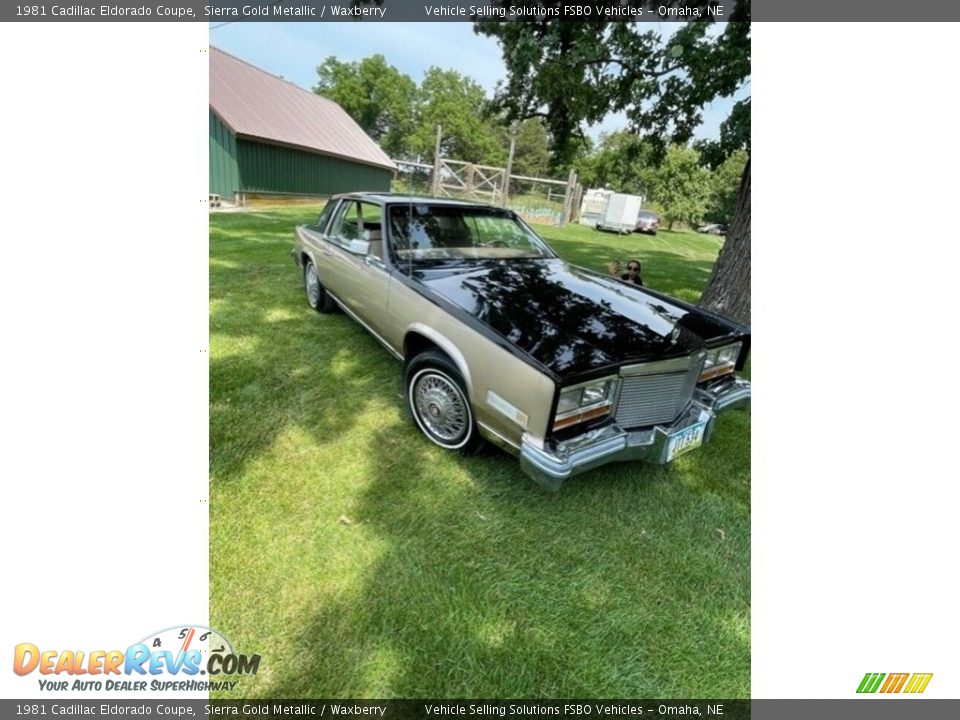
[412,67,507,166]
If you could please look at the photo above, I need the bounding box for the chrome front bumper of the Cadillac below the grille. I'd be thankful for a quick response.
[520,376,750,490]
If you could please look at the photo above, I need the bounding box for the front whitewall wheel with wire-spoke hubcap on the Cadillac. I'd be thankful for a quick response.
[406,350,482,453]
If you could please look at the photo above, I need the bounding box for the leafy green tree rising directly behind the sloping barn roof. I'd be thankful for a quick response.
[313,55,417,157]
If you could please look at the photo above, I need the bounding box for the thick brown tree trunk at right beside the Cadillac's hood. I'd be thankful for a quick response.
[700,158,750,325]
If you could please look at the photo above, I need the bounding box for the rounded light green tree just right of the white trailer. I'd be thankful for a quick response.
[651,145,711,230]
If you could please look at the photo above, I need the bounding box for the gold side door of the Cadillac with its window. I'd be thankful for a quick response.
[321,200,390,339]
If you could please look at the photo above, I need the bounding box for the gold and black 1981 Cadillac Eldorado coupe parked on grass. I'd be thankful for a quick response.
[291,193,750,489]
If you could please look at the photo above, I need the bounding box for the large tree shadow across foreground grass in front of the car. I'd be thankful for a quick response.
[253,416,749,698]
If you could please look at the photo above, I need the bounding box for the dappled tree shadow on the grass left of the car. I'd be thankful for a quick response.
[210,263,396,481]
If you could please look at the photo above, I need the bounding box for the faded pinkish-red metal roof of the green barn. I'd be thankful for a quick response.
[210,47,396,170]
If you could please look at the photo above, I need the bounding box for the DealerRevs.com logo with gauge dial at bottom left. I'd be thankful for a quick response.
[13,625,260,692]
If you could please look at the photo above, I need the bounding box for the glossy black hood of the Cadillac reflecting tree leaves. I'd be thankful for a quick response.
[413,260,730,378]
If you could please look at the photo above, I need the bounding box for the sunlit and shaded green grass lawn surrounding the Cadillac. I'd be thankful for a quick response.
[210,207,750,698]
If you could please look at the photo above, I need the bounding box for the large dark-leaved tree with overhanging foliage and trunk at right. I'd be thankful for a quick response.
[474,7,750,321]
